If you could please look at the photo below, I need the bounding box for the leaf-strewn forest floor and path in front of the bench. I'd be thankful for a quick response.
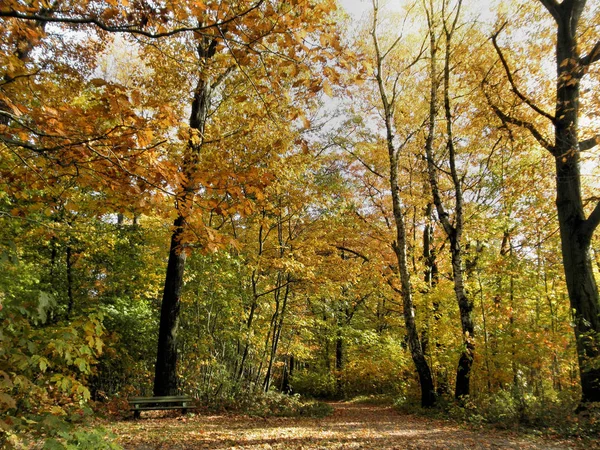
[108,402,591,450]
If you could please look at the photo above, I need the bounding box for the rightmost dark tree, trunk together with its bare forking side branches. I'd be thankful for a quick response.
[492,0,600,403]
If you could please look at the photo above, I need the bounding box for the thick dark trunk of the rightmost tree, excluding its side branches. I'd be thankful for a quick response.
[544,0,600,402]
